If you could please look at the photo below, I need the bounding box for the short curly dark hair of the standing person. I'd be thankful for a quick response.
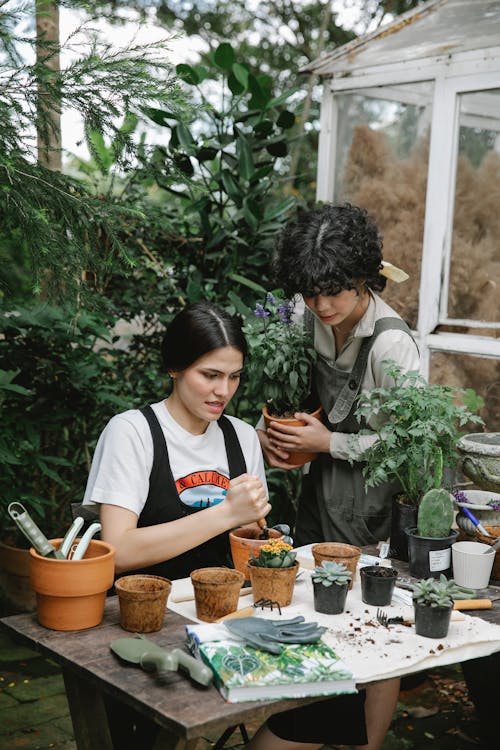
[273,203,386,297]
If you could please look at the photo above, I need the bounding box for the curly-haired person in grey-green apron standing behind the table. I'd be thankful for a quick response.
[258,204,419,546]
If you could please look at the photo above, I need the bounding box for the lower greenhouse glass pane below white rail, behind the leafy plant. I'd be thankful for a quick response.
[429,352,500,432]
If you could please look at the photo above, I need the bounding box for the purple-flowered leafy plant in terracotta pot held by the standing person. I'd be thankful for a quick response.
[239,289,321,465]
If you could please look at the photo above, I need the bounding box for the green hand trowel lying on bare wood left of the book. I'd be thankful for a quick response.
[110,634,213,686]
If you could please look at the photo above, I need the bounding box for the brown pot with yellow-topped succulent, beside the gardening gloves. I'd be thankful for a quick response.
[247,539,299,607]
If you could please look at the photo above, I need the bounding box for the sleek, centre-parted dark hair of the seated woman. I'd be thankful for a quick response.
[161,302,247,372]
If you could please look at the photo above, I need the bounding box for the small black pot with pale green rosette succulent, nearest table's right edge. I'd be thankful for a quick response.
[413,575,475,638]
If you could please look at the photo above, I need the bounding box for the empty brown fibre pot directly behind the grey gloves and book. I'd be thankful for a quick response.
[191,568,245,622]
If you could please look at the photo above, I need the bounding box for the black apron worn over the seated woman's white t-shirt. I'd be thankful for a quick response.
[134,406,247,580]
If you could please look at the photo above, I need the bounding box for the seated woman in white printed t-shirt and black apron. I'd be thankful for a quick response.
[84,302,394,750]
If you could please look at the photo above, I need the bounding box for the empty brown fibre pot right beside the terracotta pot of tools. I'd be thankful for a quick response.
[115,573,172,633]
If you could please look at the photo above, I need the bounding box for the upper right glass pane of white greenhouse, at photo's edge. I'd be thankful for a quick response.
[448,89,500,328]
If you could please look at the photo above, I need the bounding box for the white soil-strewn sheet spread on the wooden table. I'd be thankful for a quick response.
[167,570,500,684]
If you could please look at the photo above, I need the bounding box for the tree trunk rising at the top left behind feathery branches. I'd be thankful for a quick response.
[35,0,62,171]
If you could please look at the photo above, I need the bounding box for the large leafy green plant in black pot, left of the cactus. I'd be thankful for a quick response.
[352,360,483,560]
